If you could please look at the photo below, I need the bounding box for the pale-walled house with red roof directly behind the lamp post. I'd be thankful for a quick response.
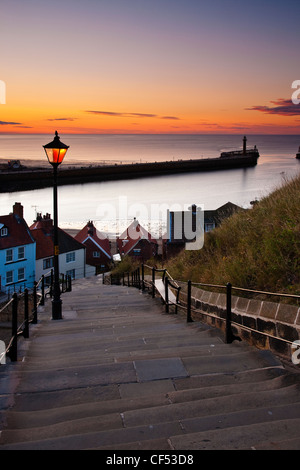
[30,213,94,280]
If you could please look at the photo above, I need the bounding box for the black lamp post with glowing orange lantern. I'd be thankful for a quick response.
[43,131,69,320]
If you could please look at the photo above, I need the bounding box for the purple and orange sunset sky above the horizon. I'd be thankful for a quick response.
[0,0,300,134]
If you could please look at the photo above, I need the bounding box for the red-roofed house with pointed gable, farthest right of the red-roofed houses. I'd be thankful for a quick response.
[117,218,158,261]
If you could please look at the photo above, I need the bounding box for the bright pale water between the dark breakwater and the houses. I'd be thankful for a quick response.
[0,159,299,237]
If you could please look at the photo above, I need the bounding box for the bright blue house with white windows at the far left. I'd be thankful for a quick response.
[0,202,36,293]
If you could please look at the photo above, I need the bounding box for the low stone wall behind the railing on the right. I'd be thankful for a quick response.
[181,286,300,360]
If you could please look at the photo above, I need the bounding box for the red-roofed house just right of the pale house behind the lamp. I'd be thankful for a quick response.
[74,221,112,274]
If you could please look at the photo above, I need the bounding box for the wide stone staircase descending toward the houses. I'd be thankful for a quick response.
[0,277,300,451]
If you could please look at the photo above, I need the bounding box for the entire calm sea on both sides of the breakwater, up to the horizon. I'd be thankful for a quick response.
[0,133,300,236]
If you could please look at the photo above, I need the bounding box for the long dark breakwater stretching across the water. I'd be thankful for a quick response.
[0,153,258,193]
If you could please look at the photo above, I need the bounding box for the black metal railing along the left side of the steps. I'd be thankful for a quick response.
[0,271,72,364]
